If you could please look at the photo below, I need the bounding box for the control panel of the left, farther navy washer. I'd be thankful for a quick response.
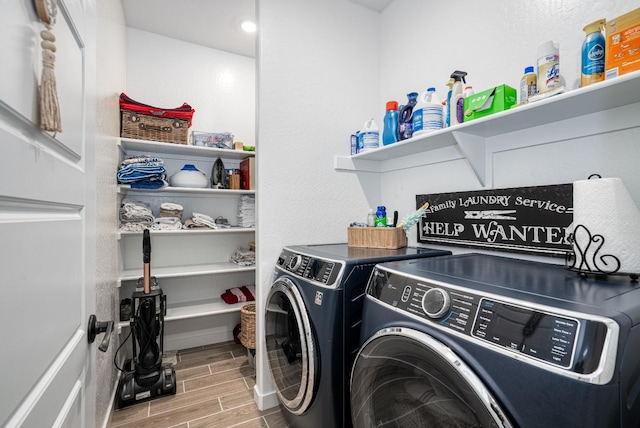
[276,250,344,287]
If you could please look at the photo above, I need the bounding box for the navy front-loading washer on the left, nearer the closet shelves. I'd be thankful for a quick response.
[265,244,451,428]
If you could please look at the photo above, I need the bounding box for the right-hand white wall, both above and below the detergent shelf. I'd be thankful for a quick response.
[376,0,640,251]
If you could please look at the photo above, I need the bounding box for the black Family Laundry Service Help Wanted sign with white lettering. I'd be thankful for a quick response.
[416,184,573,256]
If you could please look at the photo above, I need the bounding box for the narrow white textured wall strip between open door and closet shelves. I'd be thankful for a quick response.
[95,2,126,426]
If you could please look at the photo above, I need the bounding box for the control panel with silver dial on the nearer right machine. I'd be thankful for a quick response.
[367,266,606,371]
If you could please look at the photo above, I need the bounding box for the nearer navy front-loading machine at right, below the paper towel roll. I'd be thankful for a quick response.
[351,254,640,428]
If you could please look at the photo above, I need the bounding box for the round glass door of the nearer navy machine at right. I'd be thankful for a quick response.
[351,328,512,428]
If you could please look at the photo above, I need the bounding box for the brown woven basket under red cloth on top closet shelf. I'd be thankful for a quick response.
[120,110,189,144]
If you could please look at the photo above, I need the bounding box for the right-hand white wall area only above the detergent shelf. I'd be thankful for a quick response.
[378,0,640,100]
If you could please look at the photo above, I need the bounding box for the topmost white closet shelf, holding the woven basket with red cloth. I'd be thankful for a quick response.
[120,138,256,159]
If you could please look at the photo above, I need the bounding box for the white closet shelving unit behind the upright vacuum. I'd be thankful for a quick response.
[117,138,256,350]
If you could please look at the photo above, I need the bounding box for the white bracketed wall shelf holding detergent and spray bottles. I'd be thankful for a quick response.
[334,71,640,185]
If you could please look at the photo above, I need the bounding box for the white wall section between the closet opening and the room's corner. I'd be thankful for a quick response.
[256,0,380,406]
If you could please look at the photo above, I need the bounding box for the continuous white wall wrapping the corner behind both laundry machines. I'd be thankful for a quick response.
[255,0,640,407]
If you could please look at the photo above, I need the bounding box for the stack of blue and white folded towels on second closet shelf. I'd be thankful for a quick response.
[116,155,169,189]
